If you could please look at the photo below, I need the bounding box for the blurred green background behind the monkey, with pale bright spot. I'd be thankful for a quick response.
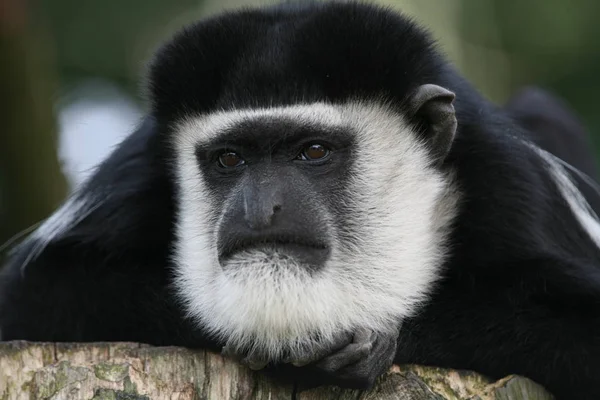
[0,0,600,248]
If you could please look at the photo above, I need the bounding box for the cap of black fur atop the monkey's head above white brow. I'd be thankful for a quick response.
[148,1,448,119]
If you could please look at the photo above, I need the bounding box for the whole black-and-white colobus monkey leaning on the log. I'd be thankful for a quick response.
[0,1,600,399]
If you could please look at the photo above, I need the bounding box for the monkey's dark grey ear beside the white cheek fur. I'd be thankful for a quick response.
[408,84,457,164]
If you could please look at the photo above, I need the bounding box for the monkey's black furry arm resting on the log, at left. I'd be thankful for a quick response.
[0,241,177,344]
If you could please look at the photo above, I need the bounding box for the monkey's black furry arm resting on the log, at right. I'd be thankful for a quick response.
[395,257,600,400]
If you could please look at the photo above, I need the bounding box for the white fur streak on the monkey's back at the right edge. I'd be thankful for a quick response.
[525,141,600,248]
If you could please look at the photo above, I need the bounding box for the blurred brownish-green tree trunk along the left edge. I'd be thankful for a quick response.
[0,0,68,250]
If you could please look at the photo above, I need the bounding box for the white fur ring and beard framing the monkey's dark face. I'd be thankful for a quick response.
[174,102,459,361]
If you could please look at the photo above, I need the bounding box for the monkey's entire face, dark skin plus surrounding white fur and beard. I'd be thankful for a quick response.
[174,103,455,360]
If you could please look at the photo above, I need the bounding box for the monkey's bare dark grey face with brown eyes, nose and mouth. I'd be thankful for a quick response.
[204,117,342,275]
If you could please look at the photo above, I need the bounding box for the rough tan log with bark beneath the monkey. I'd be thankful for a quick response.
[0,342,552,400]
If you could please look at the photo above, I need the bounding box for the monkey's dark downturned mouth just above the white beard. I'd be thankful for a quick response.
[219,236,330,269]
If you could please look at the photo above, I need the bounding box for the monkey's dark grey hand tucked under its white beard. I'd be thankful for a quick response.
[286,329,399,389]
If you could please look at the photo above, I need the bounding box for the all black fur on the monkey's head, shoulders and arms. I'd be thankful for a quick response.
[0,3,600,399]
